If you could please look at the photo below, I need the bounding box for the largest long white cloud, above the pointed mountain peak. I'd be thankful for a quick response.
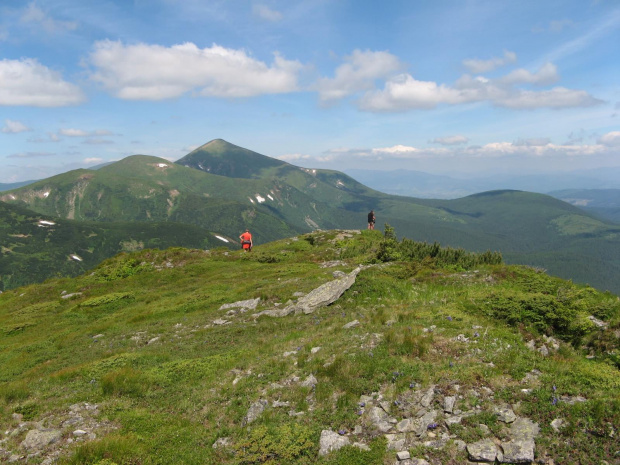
[90,40,302,100]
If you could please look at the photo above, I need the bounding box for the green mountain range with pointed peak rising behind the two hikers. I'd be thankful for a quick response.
[0,139,620,293]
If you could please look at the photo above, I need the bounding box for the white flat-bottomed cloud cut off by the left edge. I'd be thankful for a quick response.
[0,58,84,107]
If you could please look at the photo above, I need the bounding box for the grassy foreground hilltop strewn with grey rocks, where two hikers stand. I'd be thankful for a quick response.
[0,231,620,465]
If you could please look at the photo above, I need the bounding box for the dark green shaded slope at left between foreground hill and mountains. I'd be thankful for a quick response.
[0,202,232,291]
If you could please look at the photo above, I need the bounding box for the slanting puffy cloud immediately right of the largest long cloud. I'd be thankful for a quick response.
[317,50,404,103]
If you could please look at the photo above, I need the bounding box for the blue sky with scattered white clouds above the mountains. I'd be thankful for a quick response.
[0,0,620,183]
